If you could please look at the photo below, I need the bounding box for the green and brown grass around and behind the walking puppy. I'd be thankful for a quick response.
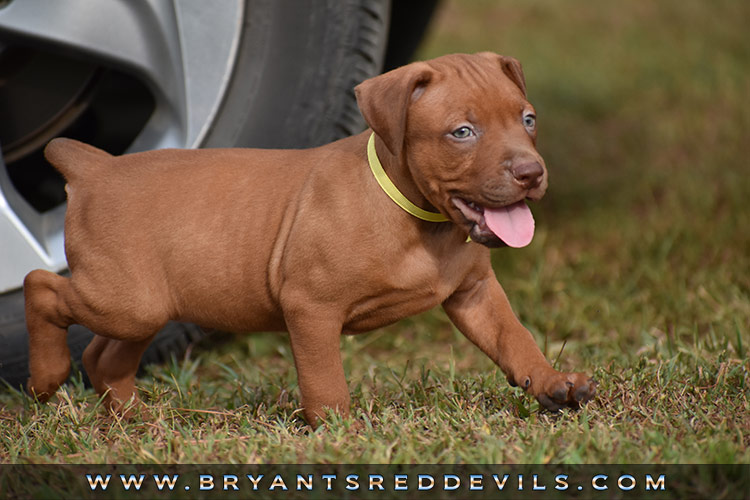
[0,0,750,463]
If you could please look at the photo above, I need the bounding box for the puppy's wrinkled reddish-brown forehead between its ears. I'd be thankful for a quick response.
[415,55,529,120]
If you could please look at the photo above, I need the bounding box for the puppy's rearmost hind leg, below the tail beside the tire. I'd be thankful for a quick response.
[23,270,73,401]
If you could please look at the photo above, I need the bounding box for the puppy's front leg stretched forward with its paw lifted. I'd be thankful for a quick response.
[443,268,596,411]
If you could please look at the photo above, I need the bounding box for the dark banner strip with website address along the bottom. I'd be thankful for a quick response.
[0,464,750,500]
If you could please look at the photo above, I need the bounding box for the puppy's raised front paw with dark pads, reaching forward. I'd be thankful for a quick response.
[508,370,597,411]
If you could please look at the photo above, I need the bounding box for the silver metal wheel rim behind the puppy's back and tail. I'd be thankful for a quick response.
[0,0,244,293]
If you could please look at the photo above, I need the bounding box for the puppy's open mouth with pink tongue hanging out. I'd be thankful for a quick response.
[452,197,534,248]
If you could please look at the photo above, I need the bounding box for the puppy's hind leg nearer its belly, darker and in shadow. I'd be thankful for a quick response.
[82,333,155,412]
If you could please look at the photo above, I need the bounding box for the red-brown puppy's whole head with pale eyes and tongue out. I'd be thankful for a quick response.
[355,52,547,247]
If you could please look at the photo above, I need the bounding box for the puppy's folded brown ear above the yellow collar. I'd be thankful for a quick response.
[354,62,433,156]
